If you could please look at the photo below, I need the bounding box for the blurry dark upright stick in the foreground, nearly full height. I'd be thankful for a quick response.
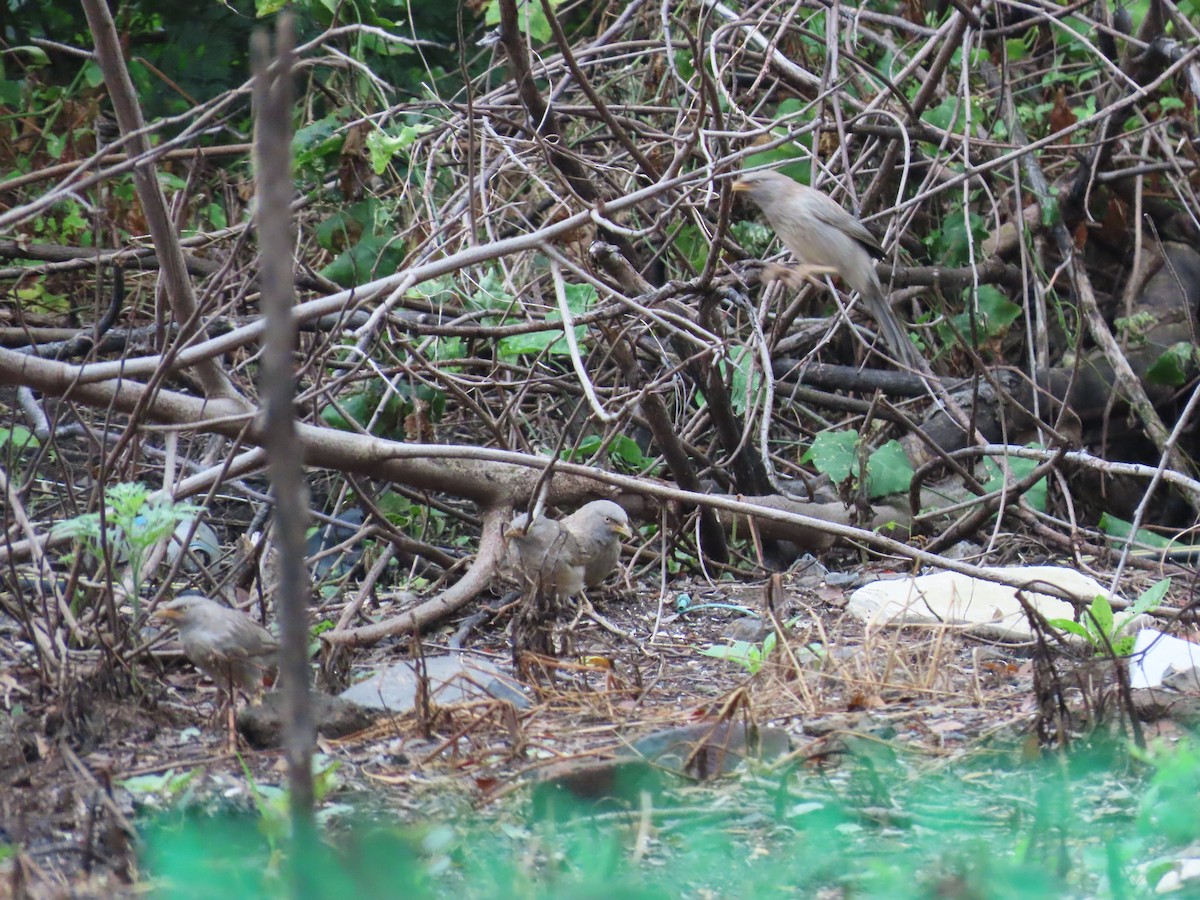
[251,13,317,830]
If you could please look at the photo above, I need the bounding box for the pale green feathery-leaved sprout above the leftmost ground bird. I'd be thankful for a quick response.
[50,481,202,618]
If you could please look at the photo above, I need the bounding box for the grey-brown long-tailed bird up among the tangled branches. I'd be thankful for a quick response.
[733,172,919,367]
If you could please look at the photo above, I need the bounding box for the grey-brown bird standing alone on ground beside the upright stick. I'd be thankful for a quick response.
[154,592,280,744]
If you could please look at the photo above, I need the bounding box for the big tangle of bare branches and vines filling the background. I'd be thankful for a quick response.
[0,0,1200,672]
